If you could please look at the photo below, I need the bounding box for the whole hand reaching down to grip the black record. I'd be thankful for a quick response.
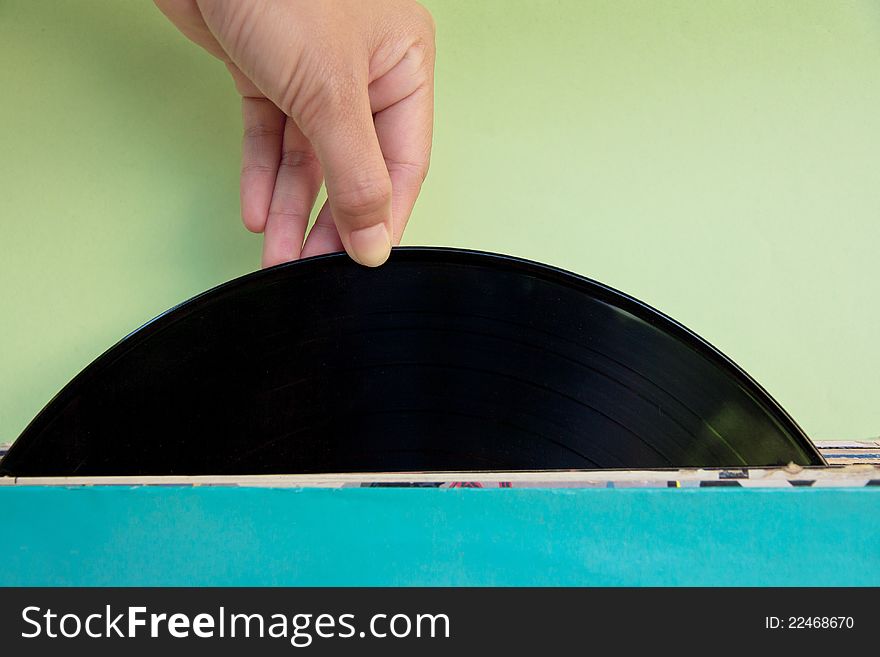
[156,0,435,267]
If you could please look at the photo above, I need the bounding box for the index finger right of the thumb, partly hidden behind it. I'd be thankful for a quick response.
[375,78,434,245]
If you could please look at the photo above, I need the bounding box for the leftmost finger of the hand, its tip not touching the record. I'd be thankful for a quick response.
[241,98,285,233]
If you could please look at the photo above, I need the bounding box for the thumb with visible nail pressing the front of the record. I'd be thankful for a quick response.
[294,82,393,267]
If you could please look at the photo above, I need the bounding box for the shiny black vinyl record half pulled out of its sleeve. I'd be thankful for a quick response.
[0,248,824,476]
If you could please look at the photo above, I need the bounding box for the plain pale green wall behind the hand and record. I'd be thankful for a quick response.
[0,0,880,442]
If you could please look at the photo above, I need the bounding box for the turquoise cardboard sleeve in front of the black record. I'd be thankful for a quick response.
[0,486,880,586]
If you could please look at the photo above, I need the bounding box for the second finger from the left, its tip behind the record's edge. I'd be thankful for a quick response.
[263,118,321,267]
